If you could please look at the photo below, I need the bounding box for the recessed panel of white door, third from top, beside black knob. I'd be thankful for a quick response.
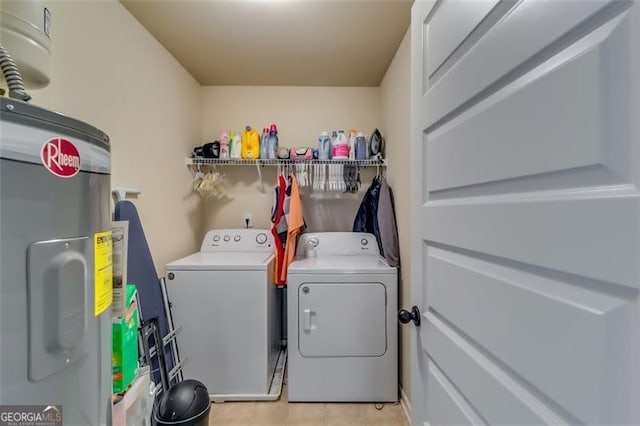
[426,248,635,418]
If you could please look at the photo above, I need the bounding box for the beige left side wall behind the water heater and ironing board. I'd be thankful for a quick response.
[31,0,201,274]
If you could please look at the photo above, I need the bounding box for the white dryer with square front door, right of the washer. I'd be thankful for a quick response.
[287,232,398,402]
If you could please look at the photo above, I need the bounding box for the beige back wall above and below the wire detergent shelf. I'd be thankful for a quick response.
[201,86,382,231]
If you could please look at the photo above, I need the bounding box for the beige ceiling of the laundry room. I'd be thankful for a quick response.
[120,0,413,86]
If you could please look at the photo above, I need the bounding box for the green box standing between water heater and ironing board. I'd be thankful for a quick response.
[111,284,138,394]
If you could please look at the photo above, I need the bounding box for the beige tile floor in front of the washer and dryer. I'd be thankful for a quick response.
[209,385,409,426]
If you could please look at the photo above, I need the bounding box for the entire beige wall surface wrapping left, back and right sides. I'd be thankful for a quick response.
[17,0,410,400]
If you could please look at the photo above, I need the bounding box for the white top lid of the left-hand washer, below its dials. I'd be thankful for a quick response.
[167,252,273,271]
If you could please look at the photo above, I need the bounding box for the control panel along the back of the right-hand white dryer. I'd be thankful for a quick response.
[296,232,380,257]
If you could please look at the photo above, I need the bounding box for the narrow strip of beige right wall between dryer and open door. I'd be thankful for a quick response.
[380,31,411,400]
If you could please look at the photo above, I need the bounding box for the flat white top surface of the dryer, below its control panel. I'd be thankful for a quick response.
[289,256,396,275]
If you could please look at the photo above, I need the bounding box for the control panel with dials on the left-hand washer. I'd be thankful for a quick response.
[200,229,274,252]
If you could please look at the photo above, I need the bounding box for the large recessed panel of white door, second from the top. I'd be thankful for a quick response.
[427,16,631,195]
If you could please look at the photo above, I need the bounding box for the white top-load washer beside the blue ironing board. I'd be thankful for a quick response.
[166,229,286,401]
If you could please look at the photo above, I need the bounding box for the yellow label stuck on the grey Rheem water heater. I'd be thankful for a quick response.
[93,231,113,316]
